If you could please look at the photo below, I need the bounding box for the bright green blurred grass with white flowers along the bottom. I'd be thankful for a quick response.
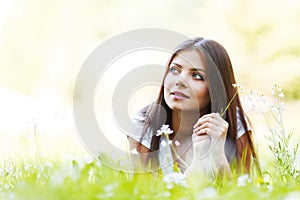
[0,156,300,199]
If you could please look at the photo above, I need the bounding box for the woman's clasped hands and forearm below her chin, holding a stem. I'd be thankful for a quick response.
[192,113,230,176]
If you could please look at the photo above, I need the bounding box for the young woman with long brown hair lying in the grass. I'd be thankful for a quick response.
[128,38,258,175]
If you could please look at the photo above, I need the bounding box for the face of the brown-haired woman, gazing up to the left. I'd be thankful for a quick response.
[164,50,210,115]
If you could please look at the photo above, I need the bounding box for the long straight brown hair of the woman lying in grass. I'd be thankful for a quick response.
[143,37,259,173]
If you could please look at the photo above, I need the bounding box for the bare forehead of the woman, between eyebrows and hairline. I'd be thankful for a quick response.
[172,49,204,68]
